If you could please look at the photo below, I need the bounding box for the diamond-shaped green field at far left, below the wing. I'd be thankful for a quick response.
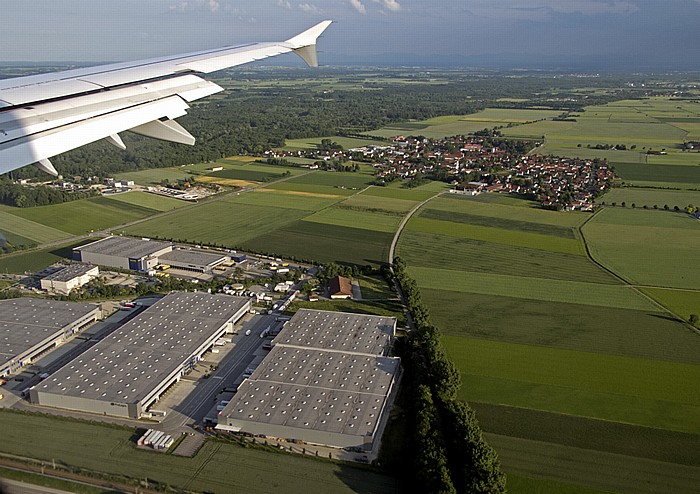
[7,197,157,235]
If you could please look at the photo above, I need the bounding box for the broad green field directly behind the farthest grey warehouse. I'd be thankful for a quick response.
[124,199,308,247]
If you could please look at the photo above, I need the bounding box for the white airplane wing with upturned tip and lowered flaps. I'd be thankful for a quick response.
[0,21,331,175]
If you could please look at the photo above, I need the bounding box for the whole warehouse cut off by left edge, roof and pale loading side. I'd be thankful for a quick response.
[0,298,102,376]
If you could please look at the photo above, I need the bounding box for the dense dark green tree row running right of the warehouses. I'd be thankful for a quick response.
[394,257,506,494]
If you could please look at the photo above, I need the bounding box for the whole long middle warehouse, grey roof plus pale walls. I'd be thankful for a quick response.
[30,292,250,419]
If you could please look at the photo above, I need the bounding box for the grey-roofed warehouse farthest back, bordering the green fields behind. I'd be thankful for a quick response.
[73,236,173,271]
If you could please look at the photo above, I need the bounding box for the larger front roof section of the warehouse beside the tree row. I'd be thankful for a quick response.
[220,346,399,436]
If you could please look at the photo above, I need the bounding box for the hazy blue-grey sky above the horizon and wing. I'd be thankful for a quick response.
[0,0,700,69]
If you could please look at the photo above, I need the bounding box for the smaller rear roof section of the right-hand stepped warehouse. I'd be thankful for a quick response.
[275,309,396,355]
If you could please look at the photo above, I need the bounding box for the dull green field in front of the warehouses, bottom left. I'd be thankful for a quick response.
[0,412,396,494]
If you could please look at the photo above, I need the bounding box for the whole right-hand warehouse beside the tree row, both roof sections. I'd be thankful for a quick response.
[217,309,399,450]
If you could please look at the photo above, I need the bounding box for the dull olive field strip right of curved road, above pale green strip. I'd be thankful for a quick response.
[399,230,620,284]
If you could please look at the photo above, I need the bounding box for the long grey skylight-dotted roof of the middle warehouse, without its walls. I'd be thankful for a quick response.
[36,292,249,403]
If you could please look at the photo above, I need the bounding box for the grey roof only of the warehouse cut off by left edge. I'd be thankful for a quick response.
[0,297,98,363]
